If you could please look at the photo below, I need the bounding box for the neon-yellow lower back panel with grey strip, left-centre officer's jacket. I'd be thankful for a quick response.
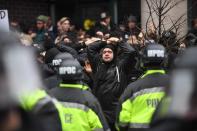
[53,99,103,131]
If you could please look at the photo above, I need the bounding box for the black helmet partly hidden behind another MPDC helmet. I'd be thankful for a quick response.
[52,52,74,68]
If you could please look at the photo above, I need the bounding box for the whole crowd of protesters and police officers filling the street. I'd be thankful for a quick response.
[0,12,197,131]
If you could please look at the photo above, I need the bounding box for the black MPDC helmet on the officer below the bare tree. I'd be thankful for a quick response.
[142,42,166,67]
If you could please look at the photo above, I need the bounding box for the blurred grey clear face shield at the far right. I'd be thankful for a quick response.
[169,69,195,117]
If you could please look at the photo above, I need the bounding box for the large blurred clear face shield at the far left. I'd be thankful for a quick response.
[4,46,43,98]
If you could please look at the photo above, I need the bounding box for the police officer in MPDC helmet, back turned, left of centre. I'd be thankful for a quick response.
[50,59,109,131]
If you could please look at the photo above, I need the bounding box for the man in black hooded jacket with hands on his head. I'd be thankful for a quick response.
[86,34,135,130]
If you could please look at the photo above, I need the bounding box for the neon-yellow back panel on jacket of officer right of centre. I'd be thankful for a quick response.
[118,87,165,128]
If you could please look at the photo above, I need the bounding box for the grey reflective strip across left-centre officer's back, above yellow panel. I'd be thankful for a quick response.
[60,102,89,111]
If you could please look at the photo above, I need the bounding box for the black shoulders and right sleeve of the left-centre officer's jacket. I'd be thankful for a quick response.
[49,84,109,131]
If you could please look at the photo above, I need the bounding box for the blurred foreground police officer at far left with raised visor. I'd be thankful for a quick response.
[0,30,73,131]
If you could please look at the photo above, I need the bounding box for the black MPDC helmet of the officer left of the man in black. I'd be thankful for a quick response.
[58,59,83,81]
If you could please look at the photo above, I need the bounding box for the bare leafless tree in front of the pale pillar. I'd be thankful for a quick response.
[146,0,187,48]
